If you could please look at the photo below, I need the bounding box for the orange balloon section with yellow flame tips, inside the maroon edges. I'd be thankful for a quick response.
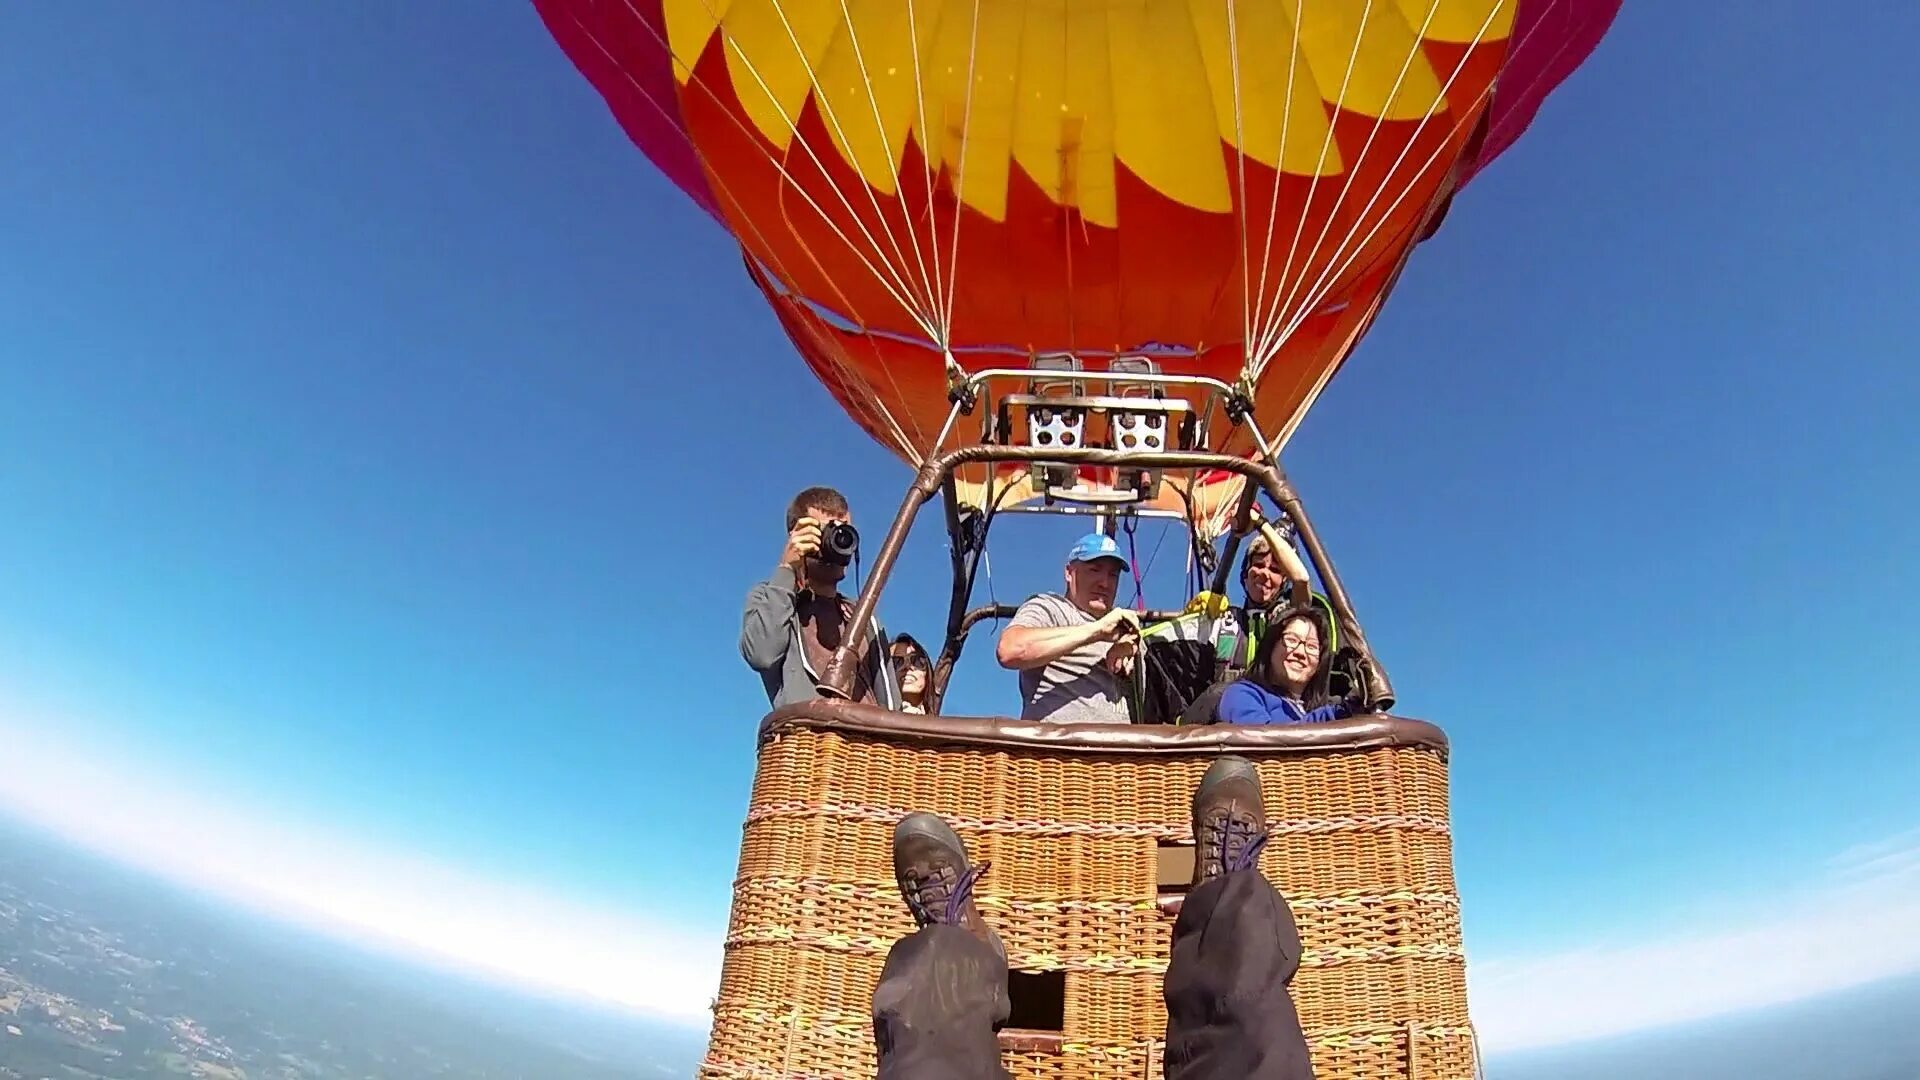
[679,0,1511,357]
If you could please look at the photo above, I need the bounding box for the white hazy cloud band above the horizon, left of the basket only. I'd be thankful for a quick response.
[0,717,718,1022]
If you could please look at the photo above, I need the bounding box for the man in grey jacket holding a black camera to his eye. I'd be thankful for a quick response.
[739,488,899,709]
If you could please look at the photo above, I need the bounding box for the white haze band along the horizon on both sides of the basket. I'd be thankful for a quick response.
[0,715,1920,1053]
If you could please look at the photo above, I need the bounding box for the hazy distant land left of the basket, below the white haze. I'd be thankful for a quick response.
[0,821,699,1080]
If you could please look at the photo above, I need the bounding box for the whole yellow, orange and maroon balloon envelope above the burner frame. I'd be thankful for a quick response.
[534,0,1619,511]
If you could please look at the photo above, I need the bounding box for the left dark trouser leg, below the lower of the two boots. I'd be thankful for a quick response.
[874,924,1012,1080]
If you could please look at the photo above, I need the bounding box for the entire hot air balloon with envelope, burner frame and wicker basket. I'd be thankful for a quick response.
[534,0,1619,1078]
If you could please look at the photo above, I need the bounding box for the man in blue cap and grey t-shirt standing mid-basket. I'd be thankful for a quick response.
[996,532,1140,724]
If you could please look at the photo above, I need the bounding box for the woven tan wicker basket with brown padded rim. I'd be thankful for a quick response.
[699,701,1475,1080]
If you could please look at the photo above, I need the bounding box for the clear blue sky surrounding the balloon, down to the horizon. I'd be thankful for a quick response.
[0,0,1920,1042]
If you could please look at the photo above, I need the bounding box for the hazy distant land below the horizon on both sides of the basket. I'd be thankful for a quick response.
[0,821,1920,1080]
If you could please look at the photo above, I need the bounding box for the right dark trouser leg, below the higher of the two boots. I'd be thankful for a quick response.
[1165,871,1313,1080]
